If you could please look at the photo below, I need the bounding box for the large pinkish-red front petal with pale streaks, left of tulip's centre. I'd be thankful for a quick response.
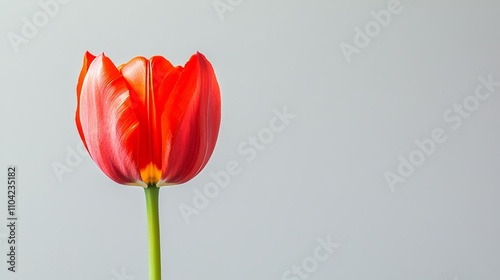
[79,55,141,184]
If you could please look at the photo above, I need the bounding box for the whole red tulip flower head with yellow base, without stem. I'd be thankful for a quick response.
[76,52,221,187]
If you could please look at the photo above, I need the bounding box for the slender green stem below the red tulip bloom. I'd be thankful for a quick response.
[144,185,161,280]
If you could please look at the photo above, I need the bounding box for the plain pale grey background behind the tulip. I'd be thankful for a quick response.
[0,0,500,280]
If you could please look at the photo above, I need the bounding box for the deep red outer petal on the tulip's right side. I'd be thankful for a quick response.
[162,53,221,184]
